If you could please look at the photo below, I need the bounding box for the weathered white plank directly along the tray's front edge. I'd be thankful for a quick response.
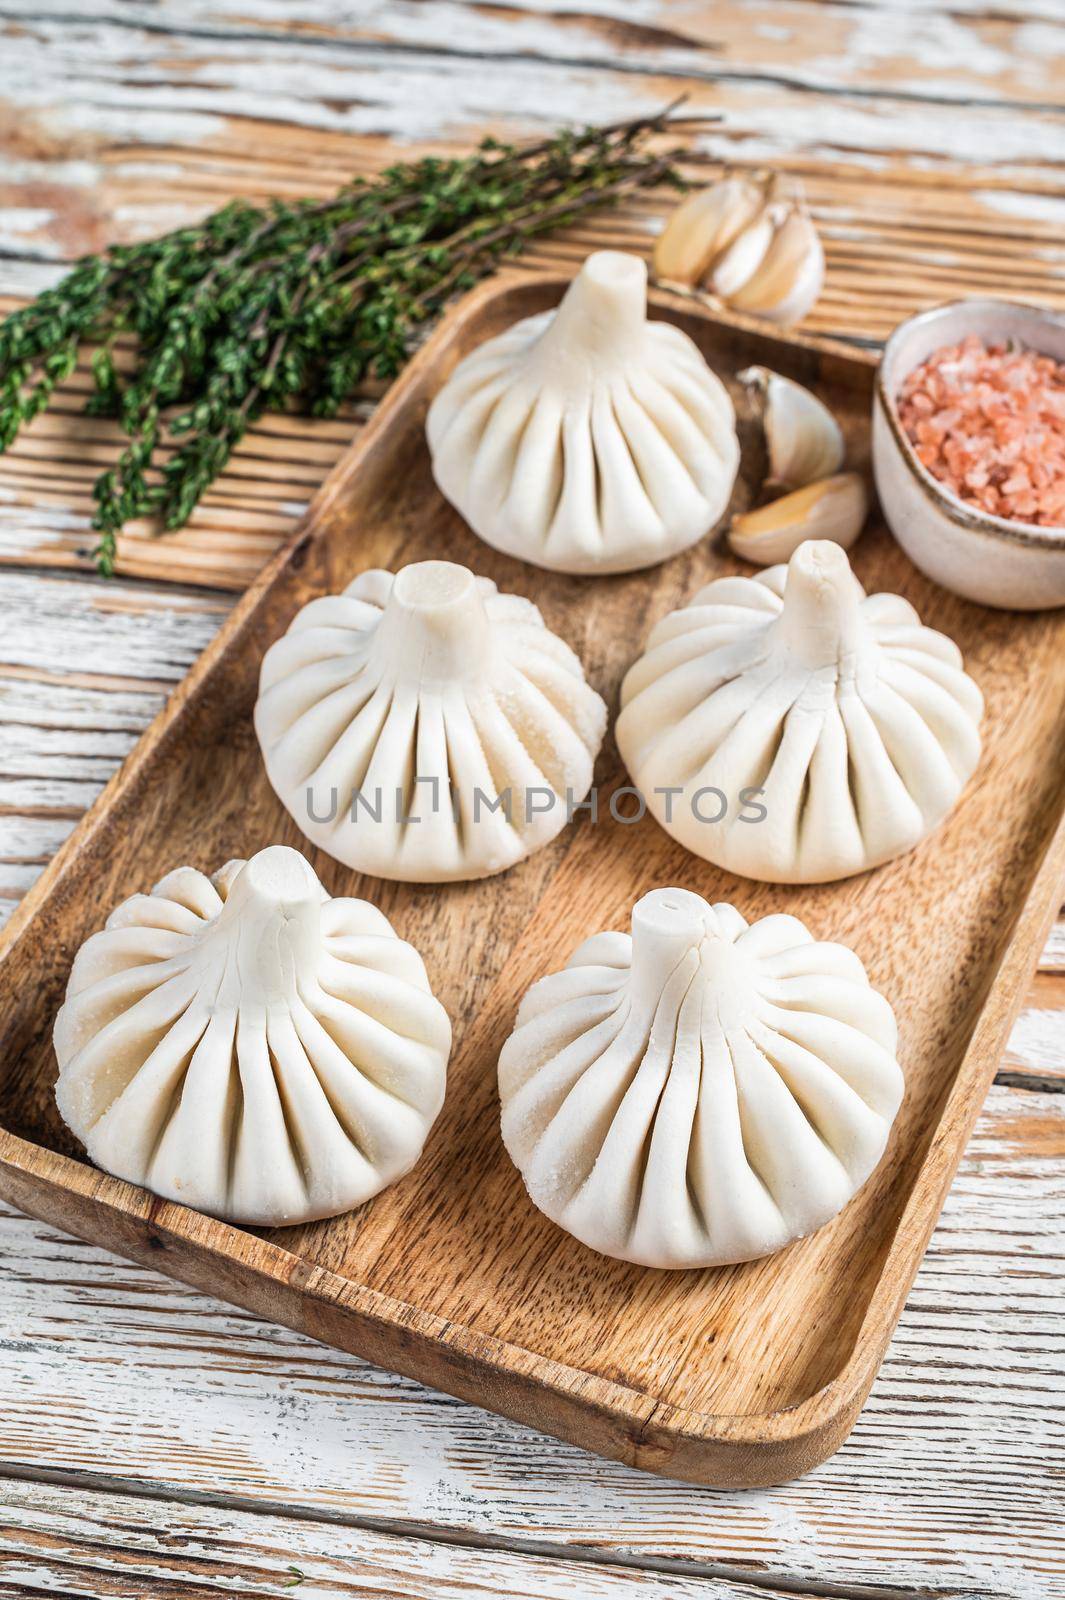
[0,1088,1065,1600]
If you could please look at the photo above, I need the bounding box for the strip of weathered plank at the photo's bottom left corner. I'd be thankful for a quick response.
[0,1478,796,1600]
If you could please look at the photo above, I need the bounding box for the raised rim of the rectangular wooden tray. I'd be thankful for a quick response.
[0,269,1065,1486]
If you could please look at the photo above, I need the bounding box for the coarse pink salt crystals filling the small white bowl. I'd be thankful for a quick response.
[899,333,1065,528]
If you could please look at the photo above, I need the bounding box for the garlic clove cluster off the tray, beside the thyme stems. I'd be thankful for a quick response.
[654,176,825,323]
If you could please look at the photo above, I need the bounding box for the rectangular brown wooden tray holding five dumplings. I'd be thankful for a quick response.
[0,277,1065,1485]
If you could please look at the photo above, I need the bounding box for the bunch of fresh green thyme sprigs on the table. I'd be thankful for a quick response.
[0,107,705,574]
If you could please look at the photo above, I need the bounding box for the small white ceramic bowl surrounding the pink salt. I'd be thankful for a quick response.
[873,299,1065,611]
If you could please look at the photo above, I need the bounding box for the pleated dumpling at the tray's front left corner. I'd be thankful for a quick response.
[54,845,451,1226]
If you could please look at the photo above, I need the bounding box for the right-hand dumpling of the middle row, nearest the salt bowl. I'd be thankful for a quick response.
[617,541,983,883]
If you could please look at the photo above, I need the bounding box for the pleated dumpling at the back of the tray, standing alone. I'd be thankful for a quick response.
[427,250,739,573]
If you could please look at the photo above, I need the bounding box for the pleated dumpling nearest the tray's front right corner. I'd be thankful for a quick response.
[499,890,902,1267]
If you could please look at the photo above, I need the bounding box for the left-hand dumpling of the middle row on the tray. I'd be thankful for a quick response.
[256,562,606,883]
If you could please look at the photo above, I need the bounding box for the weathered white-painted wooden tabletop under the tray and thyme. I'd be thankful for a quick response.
[0,0,1065,1600]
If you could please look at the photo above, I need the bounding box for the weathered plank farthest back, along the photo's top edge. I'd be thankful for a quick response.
[5,0,1065,106]
